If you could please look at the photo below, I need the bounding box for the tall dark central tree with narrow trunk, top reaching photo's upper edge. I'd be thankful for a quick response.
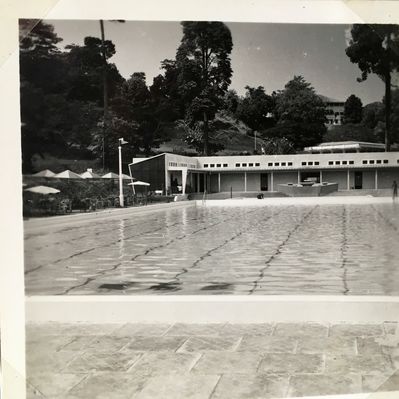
[176,22,233,155]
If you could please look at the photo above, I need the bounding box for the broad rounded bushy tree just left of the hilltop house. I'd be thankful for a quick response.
[263,76,326,150]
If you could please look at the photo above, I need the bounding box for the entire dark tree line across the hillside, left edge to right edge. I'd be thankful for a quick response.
[20,20,399,172]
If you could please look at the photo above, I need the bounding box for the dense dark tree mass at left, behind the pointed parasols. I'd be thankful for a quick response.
[20,20,177,172]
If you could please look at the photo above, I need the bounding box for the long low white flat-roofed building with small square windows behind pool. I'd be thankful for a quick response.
[129,144,399,194]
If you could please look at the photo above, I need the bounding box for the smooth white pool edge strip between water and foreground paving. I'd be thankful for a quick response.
[26,295,399,323]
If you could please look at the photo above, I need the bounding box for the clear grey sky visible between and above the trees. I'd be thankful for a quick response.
[46,20,384,105]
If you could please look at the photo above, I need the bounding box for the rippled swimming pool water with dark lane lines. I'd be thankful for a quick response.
[25,204,399,295]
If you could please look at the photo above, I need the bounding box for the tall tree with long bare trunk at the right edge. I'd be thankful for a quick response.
[346,24,399,151]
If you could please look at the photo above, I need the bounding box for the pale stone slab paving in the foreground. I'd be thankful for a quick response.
[27,323,399,399]
